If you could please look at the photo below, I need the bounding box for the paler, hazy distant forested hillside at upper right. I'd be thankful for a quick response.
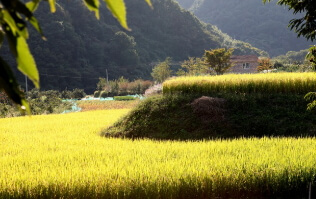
[177,0,312,56]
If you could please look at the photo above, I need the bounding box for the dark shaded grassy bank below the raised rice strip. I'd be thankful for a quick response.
[102,93,316,140]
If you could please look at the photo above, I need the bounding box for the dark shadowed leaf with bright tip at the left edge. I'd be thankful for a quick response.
[0,57,31,114]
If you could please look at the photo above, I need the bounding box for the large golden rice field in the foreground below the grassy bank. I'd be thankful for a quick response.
[0,109,316,198]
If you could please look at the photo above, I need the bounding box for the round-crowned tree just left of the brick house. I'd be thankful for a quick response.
[204,48,234,75]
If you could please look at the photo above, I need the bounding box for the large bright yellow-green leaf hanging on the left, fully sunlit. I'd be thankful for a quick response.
[16,37,39,88]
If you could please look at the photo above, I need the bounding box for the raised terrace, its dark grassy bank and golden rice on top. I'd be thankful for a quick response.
[102,73,316,140]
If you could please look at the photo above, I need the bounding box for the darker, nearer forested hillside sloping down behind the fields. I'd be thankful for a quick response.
[0,0,264,93]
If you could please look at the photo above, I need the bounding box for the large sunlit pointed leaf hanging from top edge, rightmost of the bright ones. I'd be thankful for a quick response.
[104,0,130,30]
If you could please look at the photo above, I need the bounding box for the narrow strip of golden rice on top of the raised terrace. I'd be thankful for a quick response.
[163,73,316,94]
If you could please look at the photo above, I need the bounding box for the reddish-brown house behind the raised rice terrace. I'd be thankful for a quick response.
[229,55,259,73]
